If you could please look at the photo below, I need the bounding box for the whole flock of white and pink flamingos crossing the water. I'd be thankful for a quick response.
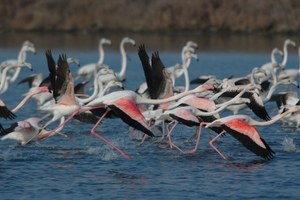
[0,37,300,160]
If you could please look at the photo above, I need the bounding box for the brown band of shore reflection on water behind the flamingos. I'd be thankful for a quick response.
[0,32,300,52]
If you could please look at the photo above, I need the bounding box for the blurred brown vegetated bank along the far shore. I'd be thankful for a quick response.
[0,0,300,34]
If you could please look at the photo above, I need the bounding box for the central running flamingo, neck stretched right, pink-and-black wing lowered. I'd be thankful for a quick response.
[42,84,214,158]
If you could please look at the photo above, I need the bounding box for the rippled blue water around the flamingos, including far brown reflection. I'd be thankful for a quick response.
[0,34,300,199]
